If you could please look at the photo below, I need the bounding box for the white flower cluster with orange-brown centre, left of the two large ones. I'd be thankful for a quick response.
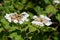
[5,12,29,24]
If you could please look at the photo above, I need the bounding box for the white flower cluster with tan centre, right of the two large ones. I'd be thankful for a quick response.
[32,15,52,26]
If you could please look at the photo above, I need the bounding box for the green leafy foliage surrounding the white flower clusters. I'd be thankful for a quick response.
[0,0,60,40]
